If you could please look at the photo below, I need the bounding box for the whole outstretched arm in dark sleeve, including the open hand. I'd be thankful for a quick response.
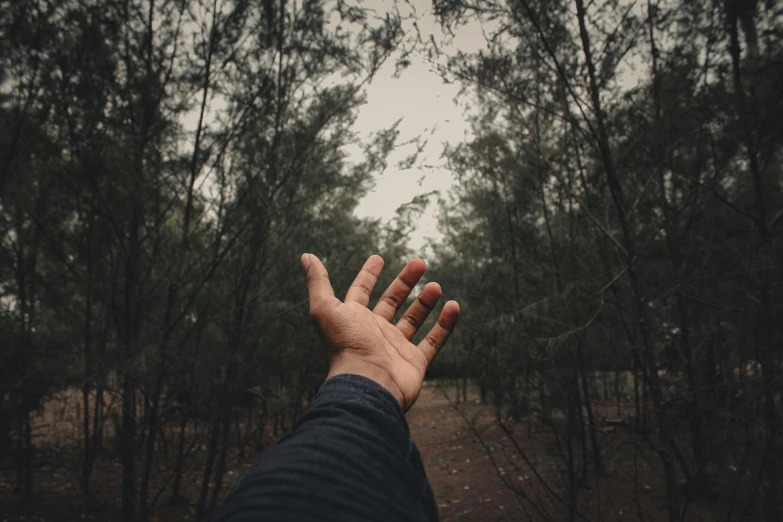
[217,254,459,522]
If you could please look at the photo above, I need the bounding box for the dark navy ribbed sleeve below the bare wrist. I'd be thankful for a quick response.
[216,375,438,522]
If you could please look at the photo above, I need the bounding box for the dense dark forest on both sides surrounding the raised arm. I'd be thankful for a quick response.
[0,0,783,522]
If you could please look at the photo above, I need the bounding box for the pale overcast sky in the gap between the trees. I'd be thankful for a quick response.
[346,0,484,254]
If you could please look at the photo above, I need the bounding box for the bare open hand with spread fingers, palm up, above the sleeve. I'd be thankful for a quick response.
[302,254,459,411]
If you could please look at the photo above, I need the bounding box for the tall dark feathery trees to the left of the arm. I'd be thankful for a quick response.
[0,0,416,522]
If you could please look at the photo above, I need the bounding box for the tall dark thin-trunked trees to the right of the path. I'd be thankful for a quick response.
[430,0,783,522]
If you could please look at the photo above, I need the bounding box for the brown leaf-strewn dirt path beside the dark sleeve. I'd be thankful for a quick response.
[407,386,526,522]
